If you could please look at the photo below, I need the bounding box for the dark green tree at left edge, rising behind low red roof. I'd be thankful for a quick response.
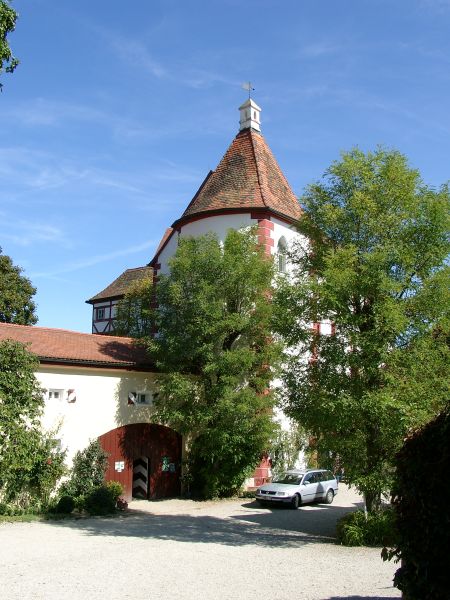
[0,248,37,325]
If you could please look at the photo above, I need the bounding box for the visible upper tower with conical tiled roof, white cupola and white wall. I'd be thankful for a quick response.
[149,98,301,277]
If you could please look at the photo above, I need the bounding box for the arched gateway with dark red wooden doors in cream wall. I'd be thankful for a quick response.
[98,423,181,501]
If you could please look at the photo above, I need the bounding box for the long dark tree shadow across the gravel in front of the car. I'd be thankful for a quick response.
[44,502,366,548]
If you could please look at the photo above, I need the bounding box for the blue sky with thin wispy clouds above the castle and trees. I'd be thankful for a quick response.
[0,0,450,332]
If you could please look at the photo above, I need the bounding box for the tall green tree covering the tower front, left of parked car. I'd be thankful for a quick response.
[149,230,279,497]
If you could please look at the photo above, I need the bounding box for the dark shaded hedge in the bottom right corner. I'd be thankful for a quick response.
[384,408,450,600]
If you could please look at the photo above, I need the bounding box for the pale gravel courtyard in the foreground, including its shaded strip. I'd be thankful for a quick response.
[0,485,401,600]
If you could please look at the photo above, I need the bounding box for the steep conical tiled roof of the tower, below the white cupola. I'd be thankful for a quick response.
[174,129,302,225]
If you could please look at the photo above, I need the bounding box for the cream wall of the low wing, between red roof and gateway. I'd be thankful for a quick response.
[36,365,155,465]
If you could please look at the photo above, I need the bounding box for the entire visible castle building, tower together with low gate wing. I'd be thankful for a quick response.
[0,99,306,499]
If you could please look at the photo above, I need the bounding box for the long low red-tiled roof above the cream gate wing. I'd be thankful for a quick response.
[0,323,152,370]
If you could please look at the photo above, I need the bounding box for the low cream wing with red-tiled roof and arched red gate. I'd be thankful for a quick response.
[0,323,179,500]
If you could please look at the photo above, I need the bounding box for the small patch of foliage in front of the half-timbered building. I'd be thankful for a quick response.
[114,277,154,338]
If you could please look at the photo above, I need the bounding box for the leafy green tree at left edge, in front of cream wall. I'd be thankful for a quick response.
[0,340,64,503]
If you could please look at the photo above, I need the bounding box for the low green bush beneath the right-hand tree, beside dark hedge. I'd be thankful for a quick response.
[336,507,396,546]
